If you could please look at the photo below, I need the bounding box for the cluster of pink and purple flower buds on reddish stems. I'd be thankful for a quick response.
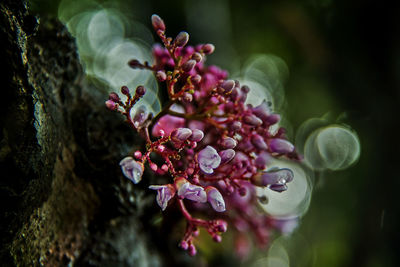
[106,15,299,255]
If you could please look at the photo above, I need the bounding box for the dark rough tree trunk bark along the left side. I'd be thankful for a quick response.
[0,0,188,266]
